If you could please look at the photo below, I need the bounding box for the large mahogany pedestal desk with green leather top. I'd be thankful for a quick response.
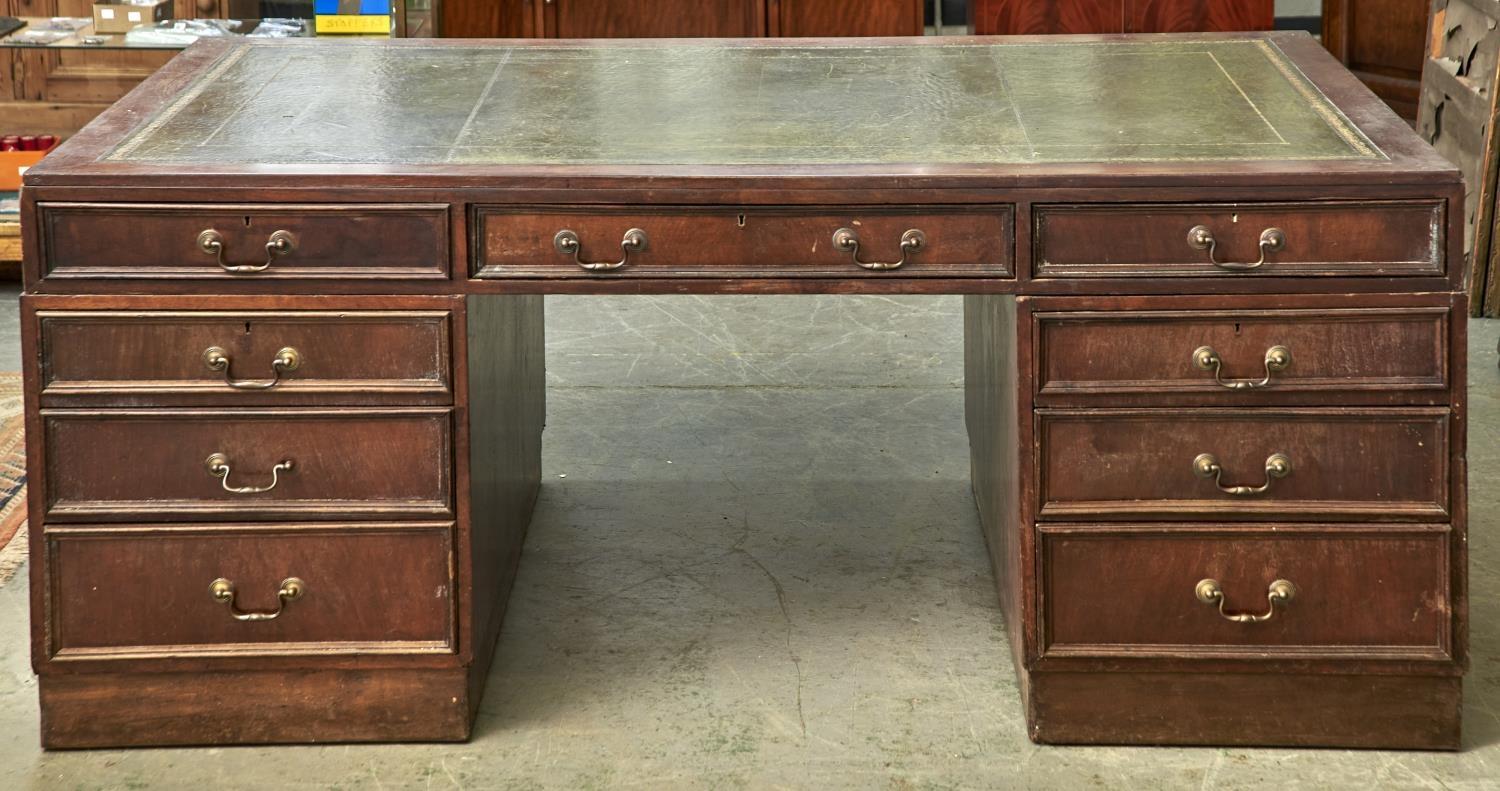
[23,33,1467,749]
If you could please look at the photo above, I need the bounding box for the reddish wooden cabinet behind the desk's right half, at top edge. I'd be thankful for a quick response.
[969,0,1275,35]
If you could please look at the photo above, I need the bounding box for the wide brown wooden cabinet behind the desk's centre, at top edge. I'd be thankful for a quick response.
[440,0,923,39]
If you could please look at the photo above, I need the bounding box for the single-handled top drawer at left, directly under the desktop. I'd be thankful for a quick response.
[39,203,449,282]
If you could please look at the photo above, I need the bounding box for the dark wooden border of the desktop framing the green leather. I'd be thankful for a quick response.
[26,32,1460,189]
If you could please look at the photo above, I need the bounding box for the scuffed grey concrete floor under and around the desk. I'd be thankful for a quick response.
[0,297,1500,789]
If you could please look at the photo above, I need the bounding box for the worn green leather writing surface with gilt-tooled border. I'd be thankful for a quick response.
[107,39,1383,165]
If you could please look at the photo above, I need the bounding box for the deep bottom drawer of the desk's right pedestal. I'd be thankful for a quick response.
[1043,525,1454,659]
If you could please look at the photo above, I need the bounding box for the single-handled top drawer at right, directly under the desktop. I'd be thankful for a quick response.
[1034,201,1446,278]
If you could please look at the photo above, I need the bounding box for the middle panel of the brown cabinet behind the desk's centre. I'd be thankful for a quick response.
[533,0,765,39]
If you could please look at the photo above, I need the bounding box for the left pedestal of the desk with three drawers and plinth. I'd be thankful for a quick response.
[21,296,545,747]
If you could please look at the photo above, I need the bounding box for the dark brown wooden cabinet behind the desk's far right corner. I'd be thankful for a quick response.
[1323,0,1428,120]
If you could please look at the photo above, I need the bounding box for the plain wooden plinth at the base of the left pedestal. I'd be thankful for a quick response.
[38,668,471,749]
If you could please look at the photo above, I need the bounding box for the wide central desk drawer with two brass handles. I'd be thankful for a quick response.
[473,206,1016,278]
